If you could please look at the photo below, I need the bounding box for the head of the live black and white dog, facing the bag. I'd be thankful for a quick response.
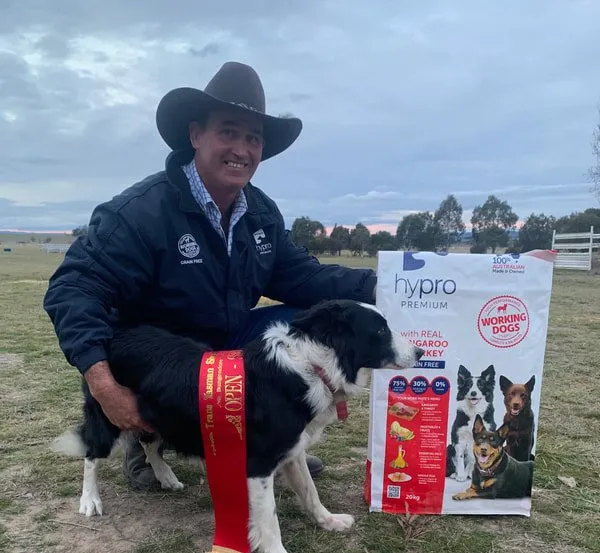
[290,300,424,383]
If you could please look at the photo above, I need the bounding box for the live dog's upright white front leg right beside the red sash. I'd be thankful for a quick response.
[248,474,287,553]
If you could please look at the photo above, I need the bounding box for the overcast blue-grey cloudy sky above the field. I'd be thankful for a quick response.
[0,0,600,233]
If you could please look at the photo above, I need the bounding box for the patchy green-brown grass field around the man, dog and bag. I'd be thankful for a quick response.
[0,246,600,553]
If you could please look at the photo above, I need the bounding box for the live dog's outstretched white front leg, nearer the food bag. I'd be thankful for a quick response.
[281,453,354,531]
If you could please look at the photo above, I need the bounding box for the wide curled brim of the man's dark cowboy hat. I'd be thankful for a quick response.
[156,87,302,161]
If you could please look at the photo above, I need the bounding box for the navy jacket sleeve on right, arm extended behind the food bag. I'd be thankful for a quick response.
[265,211,377,308]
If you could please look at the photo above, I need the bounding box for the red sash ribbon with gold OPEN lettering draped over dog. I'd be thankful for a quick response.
[198,350,250,553]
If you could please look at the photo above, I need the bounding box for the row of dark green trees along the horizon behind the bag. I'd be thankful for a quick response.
[290,194,600,256]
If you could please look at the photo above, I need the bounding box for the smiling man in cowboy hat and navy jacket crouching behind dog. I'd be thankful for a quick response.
[44,62,376,489]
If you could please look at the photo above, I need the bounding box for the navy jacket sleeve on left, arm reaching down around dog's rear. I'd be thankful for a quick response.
[44,204,153,374]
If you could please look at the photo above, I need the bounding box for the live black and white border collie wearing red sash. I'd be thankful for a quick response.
[53,300,423,553]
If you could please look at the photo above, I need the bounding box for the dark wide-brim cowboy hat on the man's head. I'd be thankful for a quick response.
[156,62,302,160]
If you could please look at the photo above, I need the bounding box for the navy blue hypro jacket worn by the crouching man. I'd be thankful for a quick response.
[44,153,376,373]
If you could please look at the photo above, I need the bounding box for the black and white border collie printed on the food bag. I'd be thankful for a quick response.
[446,365,496,482]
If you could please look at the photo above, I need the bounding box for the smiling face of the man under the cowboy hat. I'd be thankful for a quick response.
[190,109,263,194]
